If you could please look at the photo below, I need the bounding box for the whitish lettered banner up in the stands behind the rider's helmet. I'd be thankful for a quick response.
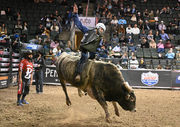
[79,17,96,28]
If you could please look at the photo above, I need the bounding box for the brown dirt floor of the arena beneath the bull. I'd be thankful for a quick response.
[0,86,180,127]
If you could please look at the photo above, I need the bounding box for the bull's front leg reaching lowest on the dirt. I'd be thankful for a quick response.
[92,87,110,123]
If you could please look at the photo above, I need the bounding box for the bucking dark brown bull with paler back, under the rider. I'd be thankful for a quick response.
[56,53,136,121]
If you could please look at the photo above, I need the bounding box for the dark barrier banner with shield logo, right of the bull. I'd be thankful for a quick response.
[121,69,172,89]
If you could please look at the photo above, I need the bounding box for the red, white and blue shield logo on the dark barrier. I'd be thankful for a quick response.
[141,72,159,86]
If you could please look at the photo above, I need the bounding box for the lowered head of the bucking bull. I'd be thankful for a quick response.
[118,83,136,111]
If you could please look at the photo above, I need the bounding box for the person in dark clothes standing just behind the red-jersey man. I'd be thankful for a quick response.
[34,52,45,94]
